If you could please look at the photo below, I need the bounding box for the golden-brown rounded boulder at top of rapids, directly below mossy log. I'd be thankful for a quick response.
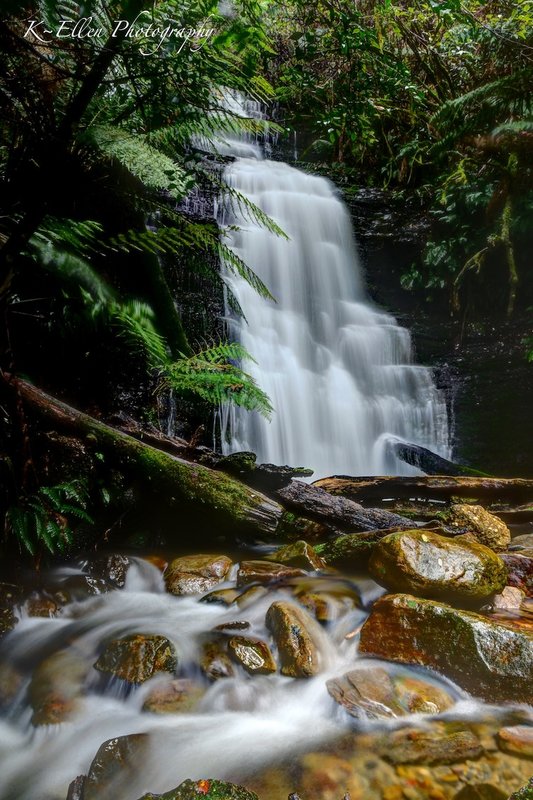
[165,555,232,595]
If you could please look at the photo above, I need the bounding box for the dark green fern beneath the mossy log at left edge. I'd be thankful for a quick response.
[5,479,93,556]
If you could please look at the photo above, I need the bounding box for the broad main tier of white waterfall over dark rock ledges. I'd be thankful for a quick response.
[218,137,449,478]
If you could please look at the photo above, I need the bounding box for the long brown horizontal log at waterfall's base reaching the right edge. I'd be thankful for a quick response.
[312,475,533,503]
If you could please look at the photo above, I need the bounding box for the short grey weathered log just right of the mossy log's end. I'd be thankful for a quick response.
[274,481,416,532]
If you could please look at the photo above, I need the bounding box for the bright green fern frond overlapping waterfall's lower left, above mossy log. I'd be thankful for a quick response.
[163,342,272,417]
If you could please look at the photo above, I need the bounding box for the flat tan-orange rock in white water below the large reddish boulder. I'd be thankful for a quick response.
[326,666,454,719]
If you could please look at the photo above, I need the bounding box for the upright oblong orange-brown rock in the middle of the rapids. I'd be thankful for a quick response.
[266,602,320,678]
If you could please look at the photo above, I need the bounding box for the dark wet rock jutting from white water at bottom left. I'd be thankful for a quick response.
[83,733,149,800]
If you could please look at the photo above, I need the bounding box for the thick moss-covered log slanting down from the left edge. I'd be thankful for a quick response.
[7,376,283,535]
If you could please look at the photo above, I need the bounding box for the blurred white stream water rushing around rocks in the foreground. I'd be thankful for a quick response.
[0,559,516,800]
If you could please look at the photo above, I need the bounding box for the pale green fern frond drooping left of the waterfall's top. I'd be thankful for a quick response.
[80,125,193,200]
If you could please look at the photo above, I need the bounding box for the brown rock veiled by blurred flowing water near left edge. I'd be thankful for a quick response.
[28,650,87,725]
